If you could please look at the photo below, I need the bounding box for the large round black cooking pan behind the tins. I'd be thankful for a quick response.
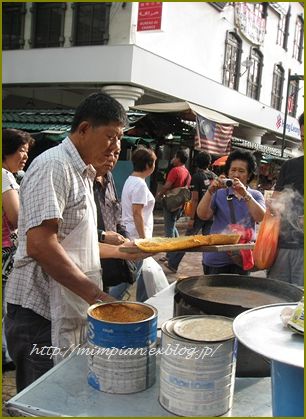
[174,274,303,377]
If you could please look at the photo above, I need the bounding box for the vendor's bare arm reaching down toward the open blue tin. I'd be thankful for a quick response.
[27,219,113,304]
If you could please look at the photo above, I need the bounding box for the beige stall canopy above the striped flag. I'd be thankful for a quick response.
[130,101,239,126]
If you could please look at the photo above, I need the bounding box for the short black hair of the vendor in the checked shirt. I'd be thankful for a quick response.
[71,92,128,133]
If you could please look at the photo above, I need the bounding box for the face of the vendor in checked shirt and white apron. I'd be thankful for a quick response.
[79,122,123,170]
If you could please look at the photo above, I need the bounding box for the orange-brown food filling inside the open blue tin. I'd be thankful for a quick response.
[90,303,154,323]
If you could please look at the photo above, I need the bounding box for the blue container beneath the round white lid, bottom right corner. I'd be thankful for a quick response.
[271,361,304,417]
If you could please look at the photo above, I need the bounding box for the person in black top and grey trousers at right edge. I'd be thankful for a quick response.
[268,112,304,287]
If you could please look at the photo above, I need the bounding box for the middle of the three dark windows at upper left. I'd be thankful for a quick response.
[31,3,66,48]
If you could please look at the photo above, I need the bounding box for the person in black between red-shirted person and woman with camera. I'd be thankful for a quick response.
[165,151,217,272]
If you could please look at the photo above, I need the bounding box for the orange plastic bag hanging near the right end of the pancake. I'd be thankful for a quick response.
[253,209,280,269]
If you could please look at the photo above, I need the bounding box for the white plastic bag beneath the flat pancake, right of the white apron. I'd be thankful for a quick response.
[142,257,169,298]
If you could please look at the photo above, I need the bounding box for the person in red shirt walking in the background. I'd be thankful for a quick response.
[157,150,191,261]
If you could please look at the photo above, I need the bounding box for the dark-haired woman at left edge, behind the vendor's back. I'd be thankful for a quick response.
[2,129,34,371]
